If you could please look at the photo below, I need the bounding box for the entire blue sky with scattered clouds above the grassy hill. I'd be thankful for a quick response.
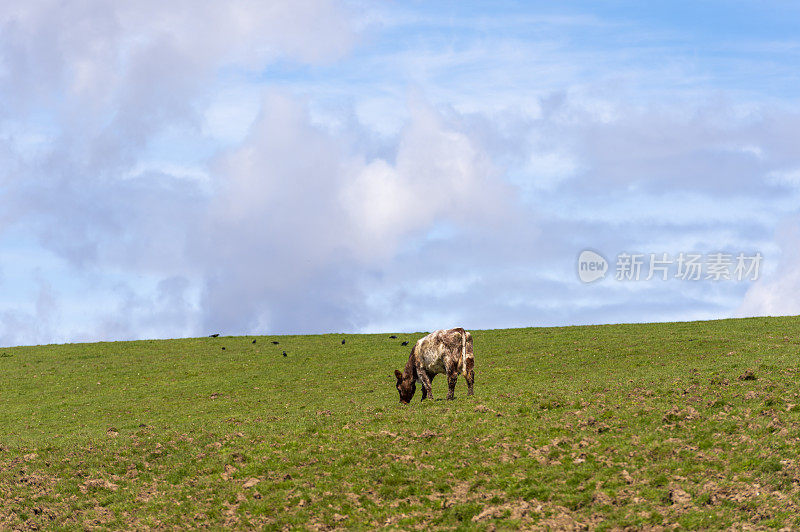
[0,0,800,346]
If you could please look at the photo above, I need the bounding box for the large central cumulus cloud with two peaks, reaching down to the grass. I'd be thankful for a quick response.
[193,93,511,331]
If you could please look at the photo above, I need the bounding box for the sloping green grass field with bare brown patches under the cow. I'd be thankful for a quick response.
[0,317,800,529]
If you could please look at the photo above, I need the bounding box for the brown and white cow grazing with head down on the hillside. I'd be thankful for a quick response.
[394,327,475,403]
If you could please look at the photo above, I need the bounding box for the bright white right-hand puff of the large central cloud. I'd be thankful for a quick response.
[342,98,511,258]
